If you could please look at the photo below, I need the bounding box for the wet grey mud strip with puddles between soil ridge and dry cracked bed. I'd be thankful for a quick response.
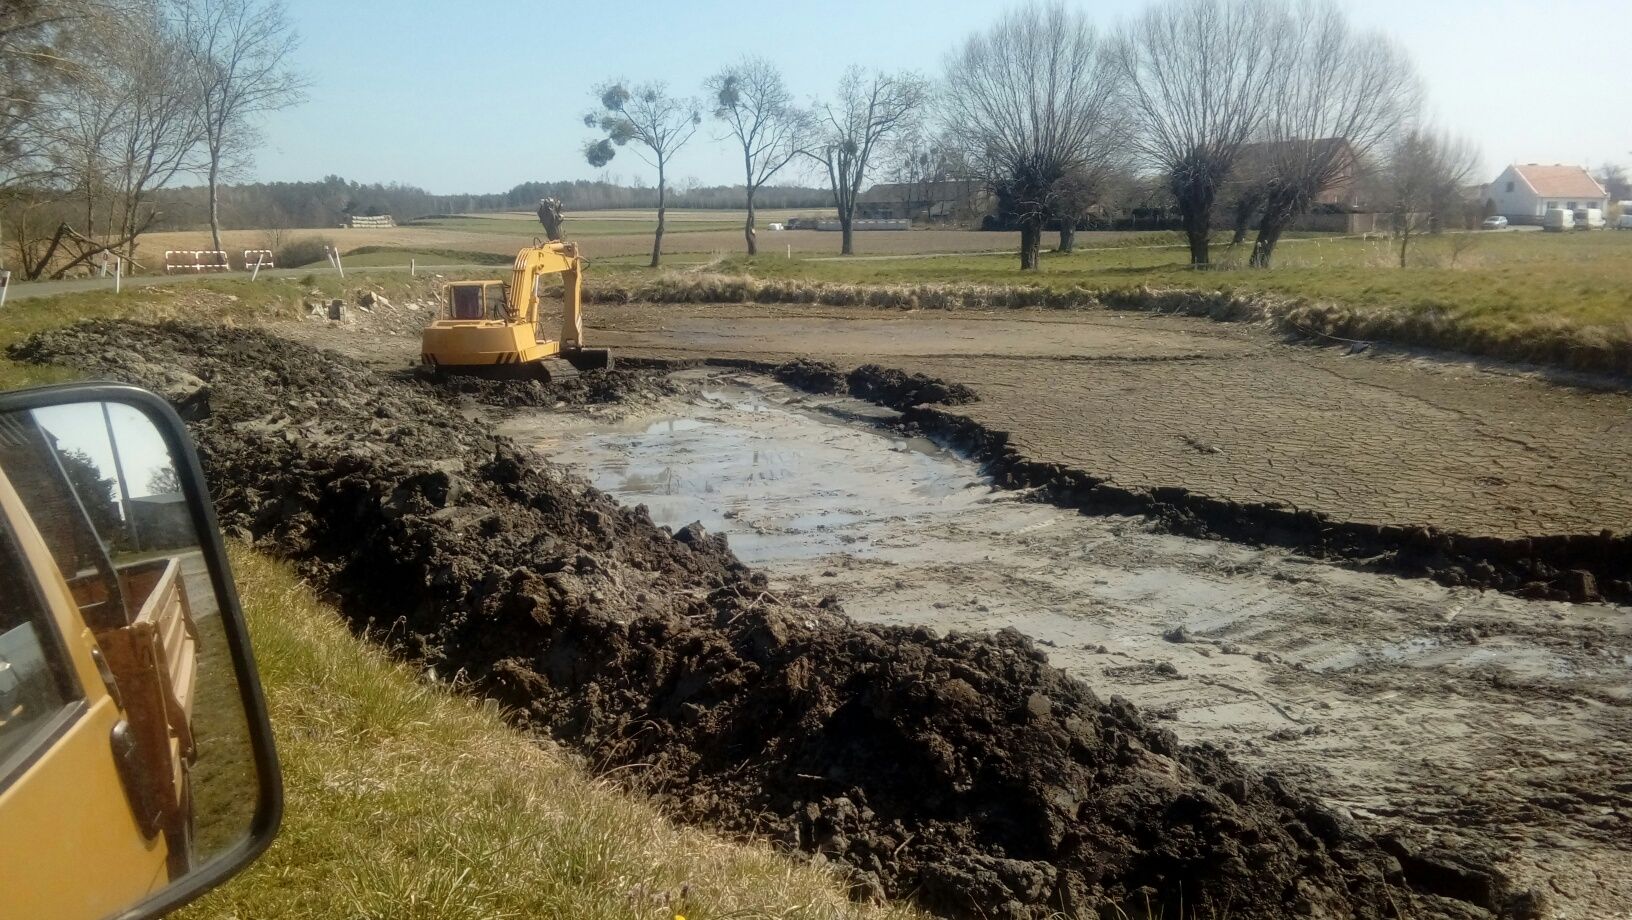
[499,369,1632,918]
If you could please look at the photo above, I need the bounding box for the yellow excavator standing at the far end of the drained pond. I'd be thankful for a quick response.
[421,240,610,377]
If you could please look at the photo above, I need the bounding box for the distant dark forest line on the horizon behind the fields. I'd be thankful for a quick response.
[150,176,832,230]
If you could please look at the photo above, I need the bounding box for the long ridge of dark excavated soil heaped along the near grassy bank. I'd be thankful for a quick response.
[13,323,1534,920]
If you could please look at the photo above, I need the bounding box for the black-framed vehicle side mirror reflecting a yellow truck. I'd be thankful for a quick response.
[0,383,282,920]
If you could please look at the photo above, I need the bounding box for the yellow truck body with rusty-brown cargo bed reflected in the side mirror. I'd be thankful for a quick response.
[0,446,197,920]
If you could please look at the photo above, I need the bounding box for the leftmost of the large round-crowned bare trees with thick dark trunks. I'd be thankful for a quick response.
[940,0,1120,269]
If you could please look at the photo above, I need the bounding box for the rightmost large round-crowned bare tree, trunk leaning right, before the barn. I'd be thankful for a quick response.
[1252,0,1421,268]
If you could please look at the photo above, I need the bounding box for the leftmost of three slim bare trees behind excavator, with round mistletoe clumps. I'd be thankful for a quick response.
[584,80,703,268]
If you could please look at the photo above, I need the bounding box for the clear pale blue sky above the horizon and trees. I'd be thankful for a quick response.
[250,0,1632,194]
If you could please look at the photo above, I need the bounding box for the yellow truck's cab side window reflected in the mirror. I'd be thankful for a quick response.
[0,530,78,780]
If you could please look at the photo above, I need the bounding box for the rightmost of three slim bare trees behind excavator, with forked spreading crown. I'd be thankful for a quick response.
[805,67,929,256]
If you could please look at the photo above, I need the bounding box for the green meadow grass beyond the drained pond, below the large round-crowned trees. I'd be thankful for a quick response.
[602,232,1632,375]
